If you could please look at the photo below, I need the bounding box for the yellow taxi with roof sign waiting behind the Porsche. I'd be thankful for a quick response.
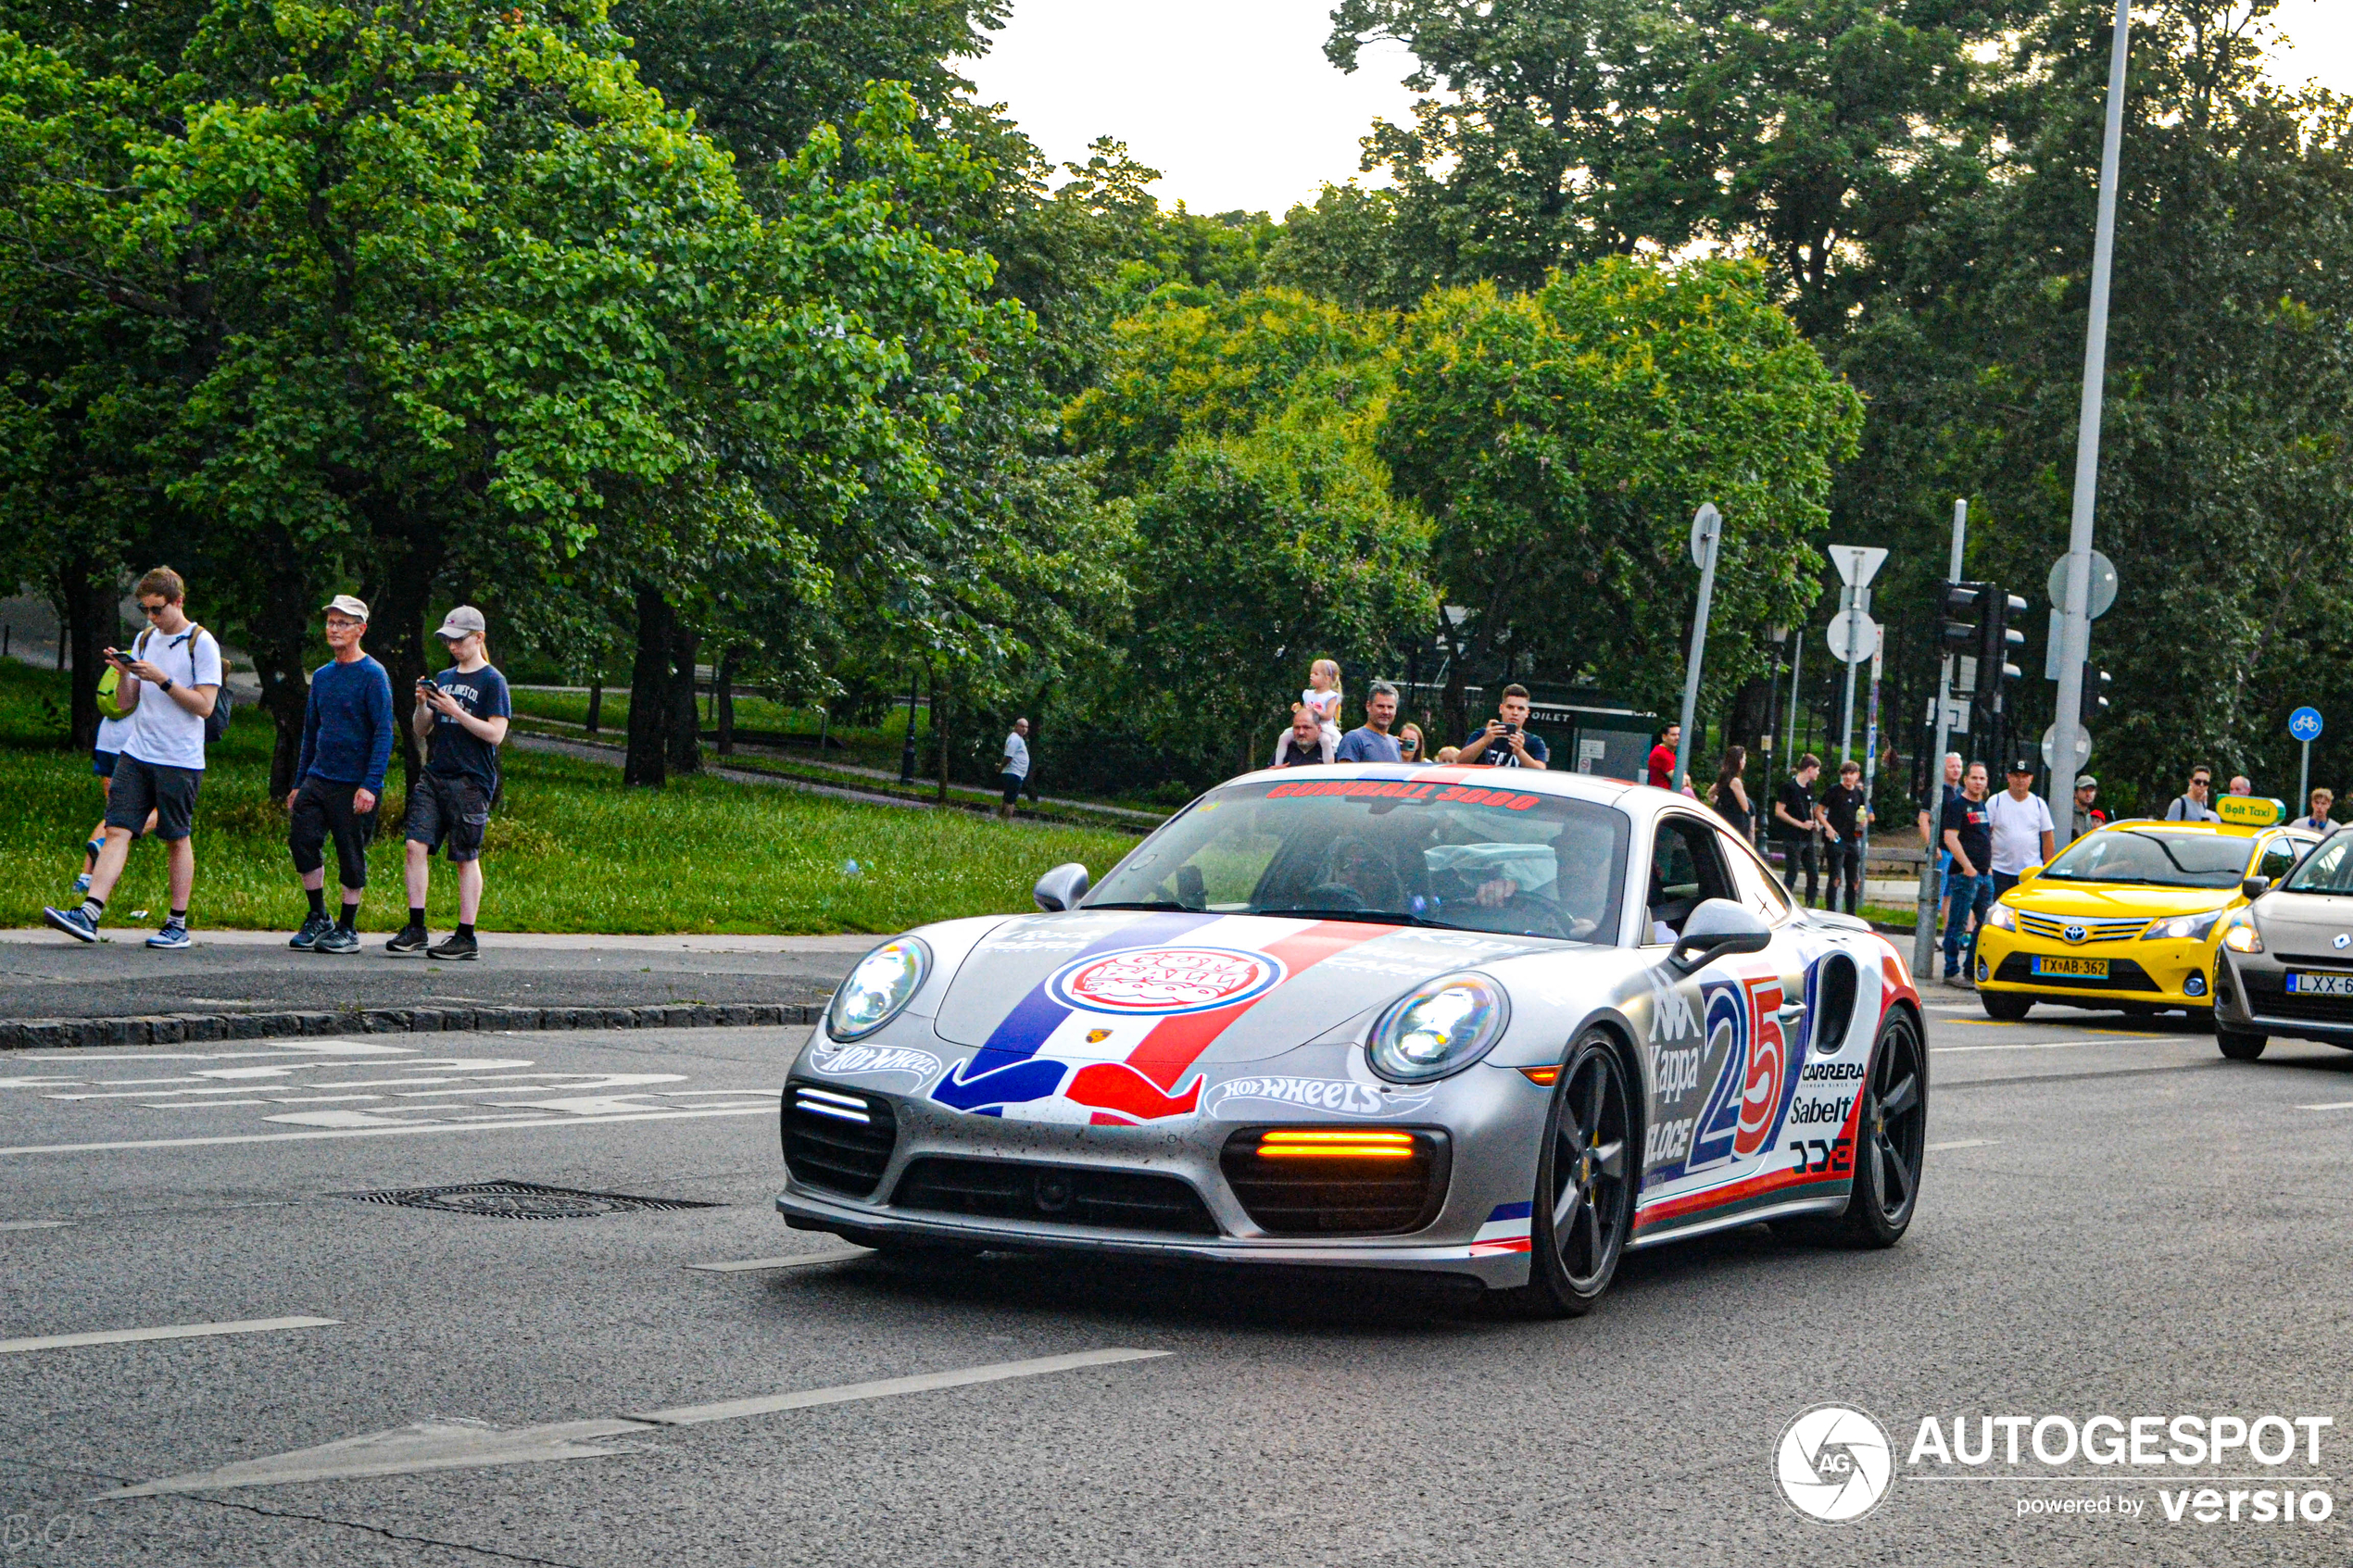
[1974,795,2320,1018]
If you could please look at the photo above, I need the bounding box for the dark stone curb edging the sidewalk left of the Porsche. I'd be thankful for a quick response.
[0,1001,826,1051]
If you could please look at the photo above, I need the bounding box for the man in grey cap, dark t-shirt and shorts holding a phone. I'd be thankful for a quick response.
[384,604,513,960]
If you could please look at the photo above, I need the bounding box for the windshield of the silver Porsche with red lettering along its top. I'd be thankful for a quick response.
[1085,778,1629,943]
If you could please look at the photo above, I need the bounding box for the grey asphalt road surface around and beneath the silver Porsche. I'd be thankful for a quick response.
[0,992,2353,1568]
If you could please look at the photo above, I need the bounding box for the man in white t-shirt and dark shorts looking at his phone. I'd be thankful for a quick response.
[40,567,221,949]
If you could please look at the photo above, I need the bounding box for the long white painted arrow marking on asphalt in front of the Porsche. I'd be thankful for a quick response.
[106,1349,1172,1502]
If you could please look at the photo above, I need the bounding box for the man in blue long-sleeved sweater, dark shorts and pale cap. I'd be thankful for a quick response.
[287,593,393,952]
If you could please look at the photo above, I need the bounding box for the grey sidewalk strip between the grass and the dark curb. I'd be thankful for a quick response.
[0,926,880,1018]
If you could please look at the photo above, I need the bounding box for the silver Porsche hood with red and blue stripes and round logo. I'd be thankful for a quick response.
[932,909,1565,1065]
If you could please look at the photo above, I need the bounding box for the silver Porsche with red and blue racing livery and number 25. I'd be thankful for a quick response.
[776,764,1927,1314]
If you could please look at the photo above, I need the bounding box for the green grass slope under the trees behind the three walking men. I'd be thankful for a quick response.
[0,660,1134,934]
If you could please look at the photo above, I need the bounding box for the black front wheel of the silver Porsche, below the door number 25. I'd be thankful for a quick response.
[1513,1030,1640,1316]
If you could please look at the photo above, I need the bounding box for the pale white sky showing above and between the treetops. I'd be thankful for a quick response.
[964,0,2353,217]
